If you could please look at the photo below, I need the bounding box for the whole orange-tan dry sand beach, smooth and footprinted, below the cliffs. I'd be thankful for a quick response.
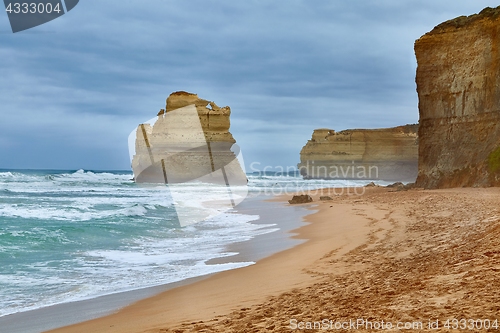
[48,187,500,333]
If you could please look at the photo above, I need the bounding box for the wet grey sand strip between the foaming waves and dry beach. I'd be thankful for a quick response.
[0,195,309,333]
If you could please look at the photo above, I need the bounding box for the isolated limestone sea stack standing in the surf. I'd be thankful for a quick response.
[132,91,247,185]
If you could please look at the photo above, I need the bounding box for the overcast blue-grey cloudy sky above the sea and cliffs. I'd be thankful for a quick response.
[0,0,499,172]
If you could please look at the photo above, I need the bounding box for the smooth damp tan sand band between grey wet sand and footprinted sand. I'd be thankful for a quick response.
[48,190,378,333]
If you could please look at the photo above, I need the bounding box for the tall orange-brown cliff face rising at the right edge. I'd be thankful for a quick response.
[415,7,500,188]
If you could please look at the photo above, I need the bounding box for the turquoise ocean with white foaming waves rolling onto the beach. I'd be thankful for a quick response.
[0,170,386,317]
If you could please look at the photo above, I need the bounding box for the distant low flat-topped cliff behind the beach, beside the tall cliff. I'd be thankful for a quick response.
[298,125,418,181]
